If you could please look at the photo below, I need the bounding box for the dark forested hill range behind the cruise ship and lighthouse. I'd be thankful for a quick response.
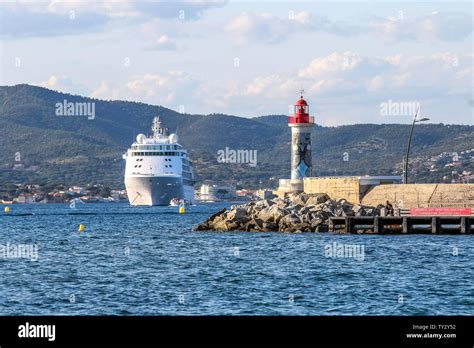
[0,85,474,188]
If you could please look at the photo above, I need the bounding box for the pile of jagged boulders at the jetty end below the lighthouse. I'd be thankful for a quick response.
[195,193,382,233]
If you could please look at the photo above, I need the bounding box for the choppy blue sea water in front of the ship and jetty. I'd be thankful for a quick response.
[0,204,474,315]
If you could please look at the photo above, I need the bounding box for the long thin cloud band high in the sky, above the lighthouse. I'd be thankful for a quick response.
[225,11,473,45]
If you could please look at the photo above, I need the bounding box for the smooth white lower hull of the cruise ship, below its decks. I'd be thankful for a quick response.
[125,175,194,206]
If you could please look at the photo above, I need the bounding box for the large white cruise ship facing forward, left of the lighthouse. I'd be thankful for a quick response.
[123,117,194,206]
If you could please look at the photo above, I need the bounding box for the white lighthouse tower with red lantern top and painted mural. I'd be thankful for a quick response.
[288,90,314,192]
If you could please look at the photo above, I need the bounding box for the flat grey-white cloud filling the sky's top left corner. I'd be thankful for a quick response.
[0,0,226,38]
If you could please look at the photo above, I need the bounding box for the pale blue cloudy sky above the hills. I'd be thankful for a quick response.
[0,0,474,126]
